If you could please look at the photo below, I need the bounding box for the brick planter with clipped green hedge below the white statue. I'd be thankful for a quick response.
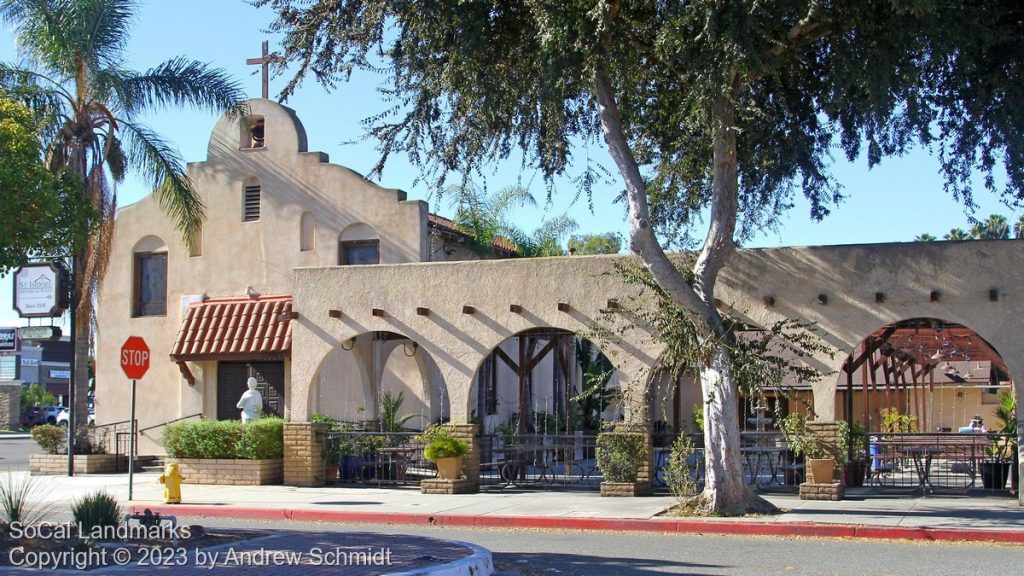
[163,418,285,486]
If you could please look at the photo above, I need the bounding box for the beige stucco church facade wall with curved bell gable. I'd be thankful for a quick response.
[96,99,429,453]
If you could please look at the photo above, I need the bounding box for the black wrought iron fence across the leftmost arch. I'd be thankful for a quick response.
[324,431,437,486]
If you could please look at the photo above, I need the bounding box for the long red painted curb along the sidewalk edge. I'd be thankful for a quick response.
[131,504,1024,544]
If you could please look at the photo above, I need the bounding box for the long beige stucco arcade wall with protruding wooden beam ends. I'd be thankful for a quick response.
[292,241,1024,434]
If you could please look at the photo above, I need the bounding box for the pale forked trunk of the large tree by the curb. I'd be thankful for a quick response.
[594,65,777,516]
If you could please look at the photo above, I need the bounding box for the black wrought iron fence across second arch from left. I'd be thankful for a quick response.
[478,433,601,490]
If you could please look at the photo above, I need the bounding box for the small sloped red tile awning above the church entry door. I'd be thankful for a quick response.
[171,294,292,362]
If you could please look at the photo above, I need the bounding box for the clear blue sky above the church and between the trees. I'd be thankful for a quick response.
[0,0,1019,326]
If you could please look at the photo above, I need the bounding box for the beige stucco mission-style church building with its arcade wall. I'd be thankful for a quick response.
[95,98,1024,498]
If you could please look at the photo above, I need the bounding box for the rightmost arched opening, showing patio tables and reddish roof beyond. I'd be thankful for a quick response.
[835,318,1019,494]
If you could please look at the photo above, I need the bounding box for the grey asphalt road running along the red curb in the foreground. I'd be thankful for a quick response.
[189,519,1024,576]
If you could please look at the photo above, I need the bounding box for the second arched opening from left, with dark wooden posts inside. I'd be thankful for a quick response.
[468,327,625,489]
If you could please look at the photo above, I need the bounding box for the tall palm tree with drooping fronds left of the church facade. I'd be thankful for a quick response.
[0,0,245,422]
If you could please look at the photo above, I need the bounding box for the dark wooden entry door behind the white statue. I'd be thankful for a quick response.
[217,362,285,420]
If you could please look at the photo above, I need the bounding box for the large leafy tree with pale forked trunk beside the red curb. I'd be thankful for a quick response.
[256,0,1024,515]
